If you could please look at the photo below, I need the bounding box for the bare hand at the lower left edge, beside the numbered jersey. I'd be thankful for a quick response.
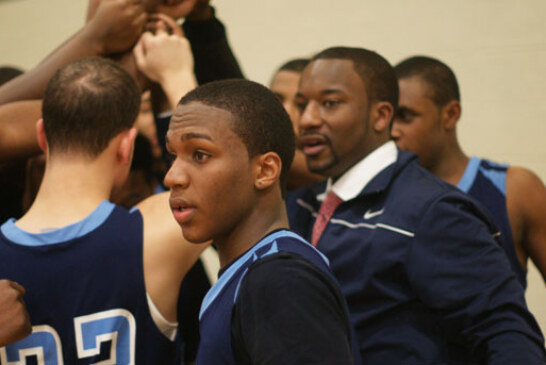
[0,279,32,347]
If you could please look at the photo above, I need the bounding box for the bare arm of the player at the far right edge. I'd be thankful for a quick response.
[506,167,546,281]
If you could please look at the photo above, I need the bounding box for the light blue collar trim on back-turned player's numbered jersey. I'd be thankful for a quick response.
[0,200,115,247]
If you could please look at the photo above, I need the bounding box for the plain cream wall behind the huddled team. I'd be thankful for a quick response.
[0,0,546,331]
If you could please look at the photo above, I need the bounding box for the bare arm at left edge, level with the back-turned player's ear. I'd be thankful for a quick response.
[0,100,42,163]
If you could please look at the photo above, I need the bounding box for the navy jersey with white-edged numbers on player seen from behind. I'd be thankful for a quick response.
[0,201,180,365]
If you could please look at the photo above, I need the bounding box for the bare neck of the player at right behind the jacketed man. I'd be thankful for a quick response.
[430,139,469,185]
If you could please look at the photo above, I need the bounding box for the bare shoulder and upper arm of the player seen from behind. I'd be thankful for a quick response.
[138,192,208,321]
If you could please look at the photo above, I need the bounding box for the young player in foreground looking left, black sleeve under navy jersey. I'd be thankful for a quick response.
[165,80,358,364]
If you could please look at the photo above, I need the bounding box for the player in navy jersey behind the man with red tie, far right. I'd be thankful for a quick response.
[391,56,546,288]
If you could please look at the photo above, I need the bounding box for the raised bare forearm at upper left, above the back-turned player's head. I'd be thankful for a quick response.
[0,27,103,105]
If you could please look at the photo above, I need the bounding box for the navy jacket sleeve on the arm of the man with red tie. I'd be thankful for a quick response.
[408,197,544,363]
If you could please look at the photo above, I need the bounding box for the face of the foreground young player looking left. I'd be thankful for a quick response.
[165,102,254,243]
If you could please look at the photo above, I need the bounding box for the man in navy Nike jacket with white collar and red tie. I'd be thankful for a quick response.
[287,47,544,364]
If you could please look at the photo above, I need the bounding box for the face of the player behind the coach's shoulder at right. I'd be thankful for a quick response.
[391,76,442,167]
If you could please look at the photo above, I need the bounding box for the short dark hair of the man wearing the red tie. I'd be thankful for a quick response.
[311,47,398,111]
